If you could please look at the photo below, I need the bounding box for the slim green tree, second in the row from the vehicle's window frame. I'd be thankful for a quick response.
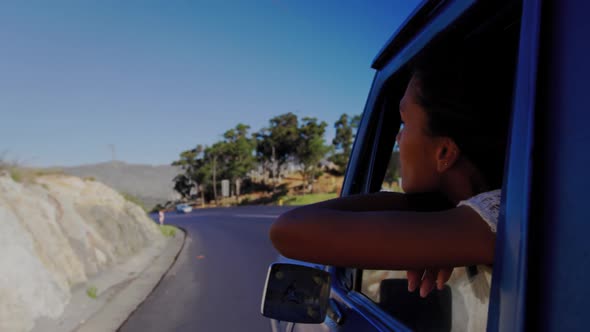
[295,117,330,190]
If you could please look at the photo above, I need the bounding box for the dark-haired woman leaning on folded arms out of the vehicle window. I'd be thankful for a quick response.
[270,40,512,297]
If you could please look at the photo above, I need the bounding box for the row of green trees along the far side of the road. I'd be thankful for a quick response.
[172,112,360,201]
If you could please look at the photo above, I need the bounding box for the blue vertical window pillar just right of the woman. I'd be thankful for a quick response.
[487,0,541,331]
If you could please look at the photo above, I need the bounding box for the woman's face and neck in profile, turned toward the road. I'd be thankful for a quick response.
[396,77,440,193]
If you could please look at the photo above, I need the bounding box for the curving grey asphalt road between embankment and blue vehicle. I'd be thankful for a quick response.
[120,206,288,332]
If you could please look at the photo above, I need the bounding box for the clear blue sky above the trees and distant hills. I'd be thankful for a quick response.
[0,0,420,166]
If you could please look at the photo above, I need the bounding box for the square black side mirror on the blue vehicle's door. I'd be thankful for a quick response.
[260,263,330,324]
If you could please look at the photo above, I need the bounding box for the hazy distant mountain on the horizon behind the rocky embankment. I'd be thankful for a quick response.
[61,161,181,209]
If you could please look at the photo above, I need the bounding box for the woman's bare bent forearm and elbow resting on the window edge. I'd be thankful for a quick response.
[270,193,495,270]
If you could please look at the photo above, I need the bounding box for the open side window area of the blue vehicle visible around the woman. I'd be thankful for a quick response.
[354,6,520,331]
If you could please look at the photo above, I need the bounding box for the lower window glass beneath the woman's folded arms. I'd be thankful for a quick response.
[361,266,491,331]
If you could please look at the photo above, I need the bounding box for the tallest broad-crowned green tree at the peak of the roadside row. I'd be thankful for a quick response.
[254,112,299,185]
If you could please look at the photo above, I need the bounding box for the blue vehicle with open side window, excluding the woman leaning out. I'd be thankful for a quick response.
[261,0,590,331]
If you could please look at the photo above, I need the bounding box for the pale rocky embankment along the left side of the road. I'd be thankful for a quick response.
[0,172,166,331]
